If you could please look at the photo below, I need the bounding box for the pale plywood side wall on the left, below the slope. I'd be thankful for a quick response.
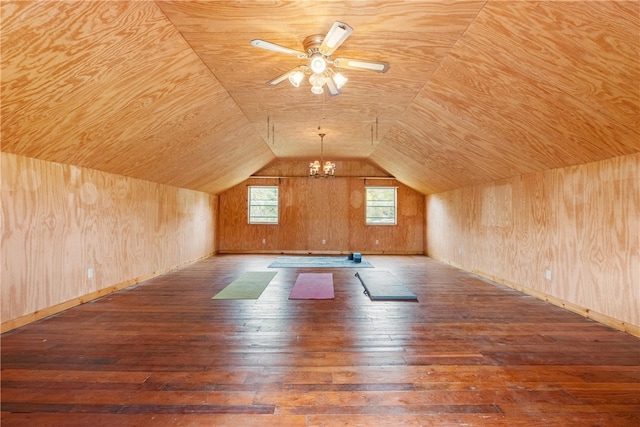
[0,153,217,332]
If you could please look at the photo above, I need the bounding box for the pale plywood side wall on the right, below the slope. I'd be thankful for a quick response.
[426,154,640,336]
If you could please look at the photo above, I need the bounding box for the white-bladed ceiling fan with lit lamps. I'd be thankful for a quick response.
[251,21,389,96]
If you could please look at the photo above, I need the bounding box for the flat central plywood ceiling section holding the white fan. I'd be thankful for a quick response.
[158,1,483,159]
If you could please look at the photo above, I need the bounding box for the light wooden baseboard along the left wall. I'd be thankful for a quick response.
[0,253,213,333]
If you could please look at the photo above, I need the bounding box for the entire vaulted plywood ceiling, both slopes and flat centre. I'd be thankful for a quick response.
[1,0,640,194]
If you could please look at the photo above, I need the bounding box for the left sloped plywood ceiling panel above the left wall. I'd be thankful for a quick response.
[2,2,274,193]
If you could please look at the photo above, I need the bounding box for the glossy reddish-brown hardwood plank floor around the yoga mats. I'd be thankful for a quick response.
[1,255,640,427]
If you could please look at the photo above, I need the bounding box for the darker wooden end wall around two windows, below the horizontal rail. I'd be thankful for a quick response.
[217,165,425,254]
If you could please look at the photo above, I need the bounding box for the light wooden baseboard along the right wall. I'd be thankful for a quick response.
[431,256,640,338]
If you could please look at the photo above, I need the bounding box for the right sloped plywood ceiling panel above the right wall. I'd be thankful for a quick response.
[371,1,640,193]
